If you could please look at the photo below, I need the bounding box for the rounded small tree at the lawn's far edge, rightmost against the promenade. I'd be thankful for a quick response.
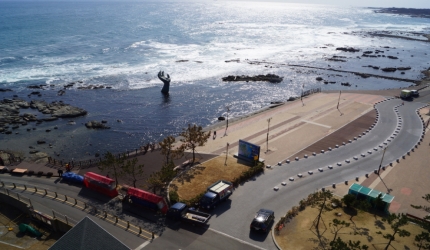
[180,124,211,163]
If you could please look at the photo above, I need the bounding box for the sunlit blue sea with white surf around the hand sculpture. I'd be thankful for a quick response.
[0,1,430,159]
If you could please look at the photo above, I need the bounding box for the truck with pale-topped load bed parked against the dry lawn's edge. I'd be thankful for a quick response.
[199,180,233,210]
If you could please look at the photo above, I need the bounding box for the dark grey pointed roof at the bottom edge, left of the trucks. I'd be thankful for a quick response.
[49,217,130,250]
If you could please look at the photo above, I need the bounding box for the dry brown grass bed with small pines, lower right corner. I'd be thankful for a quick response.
[274,191,430,250]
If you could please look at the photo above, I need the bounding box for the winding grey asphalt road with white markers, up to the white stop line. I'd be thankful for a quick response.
[202,99,424,249]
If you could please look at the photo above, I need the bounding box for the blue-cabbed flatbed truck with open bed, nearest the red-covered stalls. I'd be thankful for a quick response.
[166,202,211,226]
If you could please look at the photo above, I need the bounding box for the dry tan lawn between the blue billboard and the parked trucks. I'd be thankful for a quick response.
[170,156,251,200]
